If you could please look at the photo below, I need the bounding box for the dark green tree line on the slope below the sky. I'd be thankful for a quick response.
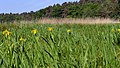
[0,0,120,22]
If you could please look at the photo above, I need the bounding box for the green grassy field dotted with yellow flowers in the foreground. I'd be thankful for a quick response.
[0,23,120,68]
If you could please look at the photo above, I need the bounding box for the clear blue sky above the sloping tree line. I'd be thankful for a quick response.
[0,0,79,13]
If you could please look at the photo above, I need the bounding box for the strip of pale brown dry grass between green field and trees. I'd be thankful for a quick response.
[16,18,120,24]
